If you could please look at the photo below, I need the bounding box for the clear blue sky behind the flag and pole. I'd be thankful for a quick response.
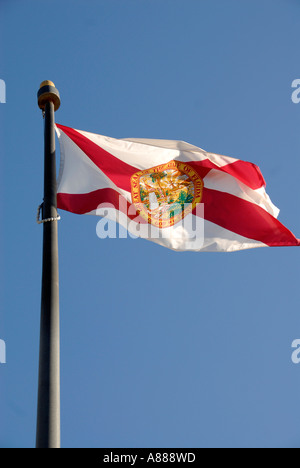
[0,0,300,448]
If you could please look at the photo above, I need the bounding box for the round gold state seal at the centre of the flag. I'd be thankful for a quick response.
[131,161,204,228]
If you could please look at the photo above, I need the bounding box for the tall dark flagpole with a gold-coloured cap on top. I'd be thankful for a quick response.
[36,81,60,448]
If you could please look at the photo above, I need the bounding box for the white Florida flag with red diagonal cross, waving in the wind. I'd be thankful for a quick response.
[56,124,300,252]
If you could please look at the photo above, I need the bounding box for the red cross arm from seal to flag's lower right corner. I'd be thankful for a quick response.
[194,187,300,247]
